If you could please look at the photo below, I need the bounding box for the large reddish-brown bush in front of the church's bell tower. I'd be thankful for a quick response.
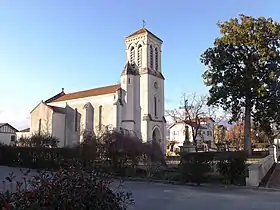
[88,131,166,176]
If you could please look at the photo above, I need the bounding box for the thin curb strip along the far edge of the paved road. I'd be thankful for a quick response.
[115,177,280,192]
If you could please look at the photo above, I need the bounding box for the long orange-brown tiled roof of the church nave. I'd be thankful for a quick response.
[49,84,121,103]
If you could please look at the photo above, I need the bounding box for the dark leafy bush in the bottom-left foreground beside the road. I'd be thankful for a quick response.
[0,162,133,210]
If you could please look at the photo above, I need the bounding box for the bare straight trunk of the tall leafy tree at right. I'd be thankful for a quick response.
[244,97,252,155]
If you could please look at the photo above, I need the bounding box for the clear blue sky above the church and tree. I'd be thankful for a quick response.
[0,0,280,128]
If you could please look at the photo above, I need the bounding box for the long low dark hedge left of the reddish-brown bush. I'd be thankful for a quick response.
[0,146,83,169]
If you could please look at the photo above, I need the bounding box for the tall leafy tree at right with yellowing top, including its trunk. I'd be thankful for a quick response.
[201,15,280,154]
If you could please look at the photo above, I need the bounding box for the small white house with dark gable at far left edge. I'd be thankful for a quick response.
[0,123,18,145]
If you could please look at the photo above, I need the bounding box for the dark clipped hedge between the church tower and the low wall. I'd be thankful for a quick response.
[180,152,247,185]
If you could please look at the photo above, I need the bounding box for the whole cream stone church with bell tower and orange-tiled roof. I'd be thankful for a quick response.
[27,28,166,148]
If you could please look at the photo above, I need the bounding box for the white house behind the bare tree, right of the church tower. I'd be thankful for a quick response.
[167,118,214,152]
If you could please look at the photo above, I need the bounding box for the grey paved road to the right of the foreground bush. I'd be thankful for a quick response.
[121,182,280,210]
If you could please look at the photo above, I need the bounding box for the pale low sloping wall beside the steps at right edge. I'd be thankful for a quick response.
[246,146,280,187]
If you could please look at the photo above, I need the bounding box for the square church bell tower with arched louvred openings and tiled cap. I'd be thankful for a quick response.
[125,27,166,148]
